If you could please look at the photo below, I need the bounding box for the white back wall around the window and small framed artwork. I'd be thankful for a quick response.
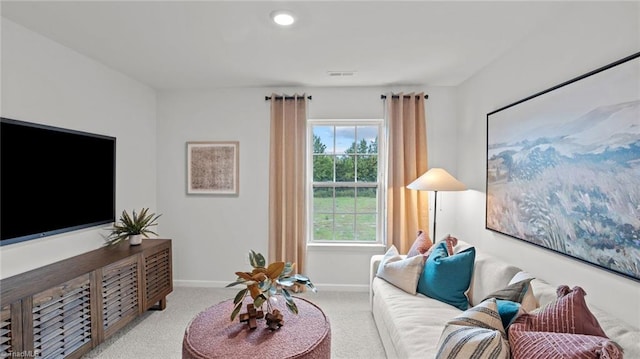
[158,88,456,290]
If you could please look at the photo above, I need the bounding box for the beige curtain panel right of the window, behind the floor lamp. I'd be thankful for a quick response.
[385,93,434,253]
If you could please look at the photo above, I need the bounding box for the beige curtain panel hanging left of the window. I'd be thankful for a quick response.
[269,94,307,273]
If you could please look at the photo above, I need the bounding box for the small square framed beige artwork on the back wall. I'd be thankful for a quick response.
[187,141,240,195]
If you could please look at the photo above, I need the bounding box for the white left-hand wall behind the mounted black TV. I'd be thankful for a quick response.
[0,18,156,278]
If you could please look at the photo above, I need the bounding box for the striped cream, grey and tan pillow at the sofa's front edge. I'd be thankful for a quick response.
[436,298,510,359]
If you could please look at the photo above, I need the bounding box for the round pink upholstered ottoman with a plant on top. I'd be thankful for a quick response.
[182,297,331,359]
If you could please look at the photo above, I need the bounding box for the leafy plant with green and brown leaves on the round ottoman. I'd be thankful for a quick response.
[226,251,318,321]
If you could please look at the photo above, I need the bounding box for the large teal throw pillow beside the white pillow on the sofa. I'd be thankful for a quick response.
[418,242,476,310]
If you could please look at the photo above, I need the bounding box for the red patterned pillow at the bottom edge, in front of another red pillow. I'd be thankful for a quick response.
[509,323,623,359]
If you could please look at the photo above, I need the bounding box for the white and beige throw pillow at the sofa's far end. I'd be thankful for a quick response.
[376,245,424,294]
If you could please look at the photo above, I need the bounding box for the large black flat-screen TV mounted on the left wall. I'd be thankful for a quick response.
[0,118,116,245]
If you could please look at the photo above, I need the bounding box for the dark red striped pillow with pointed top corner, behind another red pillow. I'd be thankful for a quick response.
[513,285,607,338]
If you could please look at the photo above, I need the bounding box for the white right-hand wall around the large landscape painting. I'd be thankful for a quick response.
[456,2,640,326]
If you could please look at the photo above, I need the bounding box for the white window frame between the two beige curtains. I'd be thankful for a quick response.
[307,119,387,246]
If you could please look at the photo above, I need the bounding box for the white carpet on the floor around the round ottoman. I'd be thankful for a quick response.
[83,287,385,359]
